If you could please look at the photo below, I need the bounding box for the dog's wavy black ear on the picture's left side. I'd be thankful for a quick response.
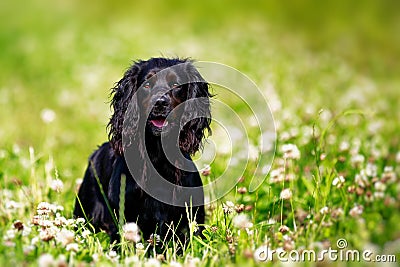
[107,62,141,155]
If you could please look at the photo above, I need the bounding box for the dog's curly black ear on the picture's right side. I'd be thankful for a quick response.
[179,64,211,154]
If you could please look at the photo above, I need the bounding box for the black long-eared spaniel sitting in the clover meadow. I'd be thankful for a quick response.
[74,58,211,247]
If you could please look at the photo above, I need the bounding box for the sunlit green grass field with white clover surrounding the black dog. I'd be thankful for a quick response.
[0,0,400,266]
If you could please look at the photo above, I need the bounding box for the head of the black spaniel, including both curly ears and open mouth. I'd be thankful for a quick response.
[108,58,211,155]
